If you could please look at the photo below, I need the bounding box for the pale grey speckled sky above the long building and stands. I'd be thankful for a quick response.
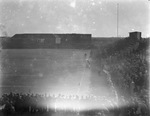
[0,0,150,37]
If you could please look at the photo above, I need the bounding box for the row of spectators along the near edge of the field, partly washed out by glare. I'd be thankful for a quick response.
[0,93,113,113]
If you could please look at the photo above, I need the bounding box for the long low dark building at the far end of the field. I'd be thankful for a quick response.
[2,34,92,49]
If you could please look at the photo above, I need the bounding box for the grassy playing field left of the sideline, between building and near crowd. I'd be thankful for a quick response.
[0,49,90,93]
